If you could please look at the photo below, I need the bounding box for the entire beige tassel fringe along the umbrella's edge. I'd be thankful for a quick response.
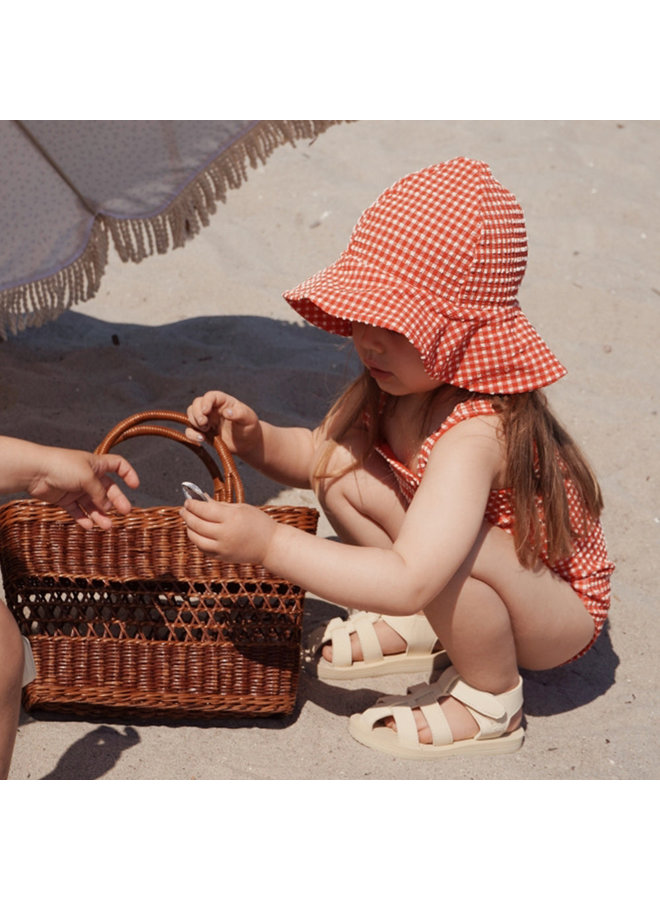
[0,120,348,340]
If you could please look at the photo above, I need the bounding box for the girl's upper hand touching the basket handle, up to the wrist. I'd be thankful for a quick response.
[186,391,260,456]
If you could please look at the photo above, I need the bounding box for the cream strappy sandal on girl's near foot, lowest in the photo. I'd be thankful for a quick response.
[348,666,525,759]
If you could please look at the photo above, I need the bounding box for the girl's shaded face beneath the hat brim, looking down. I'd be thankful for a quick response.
[352,322,441,397]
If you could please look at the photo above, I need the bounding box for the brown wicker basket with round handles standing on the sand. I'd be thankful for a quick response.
[0,410,318,718]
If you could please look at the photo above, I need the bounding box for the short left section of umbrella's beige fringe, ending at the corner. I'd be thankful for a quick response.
[0,220,108,340]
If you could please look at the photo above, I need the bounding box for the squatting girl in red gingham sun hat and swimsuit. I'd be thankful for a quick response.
[181,158,613,758]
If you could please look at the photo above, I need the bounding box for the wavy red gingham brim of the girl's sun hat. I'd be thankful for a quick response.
[283,251,566,394]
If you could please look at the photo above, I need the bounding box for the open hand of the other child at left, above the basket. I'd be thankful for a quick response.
[27,447,140,529]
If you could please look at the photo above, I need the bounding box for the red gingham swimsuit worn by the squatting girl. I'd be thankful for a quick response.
[376,400,614,659]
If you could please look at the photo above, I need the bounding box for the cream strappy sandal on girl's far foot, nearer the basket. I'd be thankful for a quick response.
[307,612,449,681]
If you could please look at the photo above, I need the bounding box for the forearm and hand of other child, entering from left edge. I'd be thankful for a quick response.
[0,437,140,528]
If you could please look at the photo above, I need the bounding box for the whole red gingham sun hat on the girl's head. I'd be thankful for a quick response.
[284,158,566,394]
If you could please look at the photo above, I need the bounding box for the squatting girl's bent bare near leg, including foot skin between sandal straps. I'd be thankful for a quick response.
[404,523,594,742]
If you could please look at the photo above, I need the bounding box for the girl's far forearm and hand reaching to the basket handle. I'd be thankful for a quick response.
[186,391,315,488]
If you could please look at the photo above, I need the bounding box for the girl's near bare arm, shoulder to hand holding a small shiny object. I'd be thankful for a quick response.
[182,419,503,615]
